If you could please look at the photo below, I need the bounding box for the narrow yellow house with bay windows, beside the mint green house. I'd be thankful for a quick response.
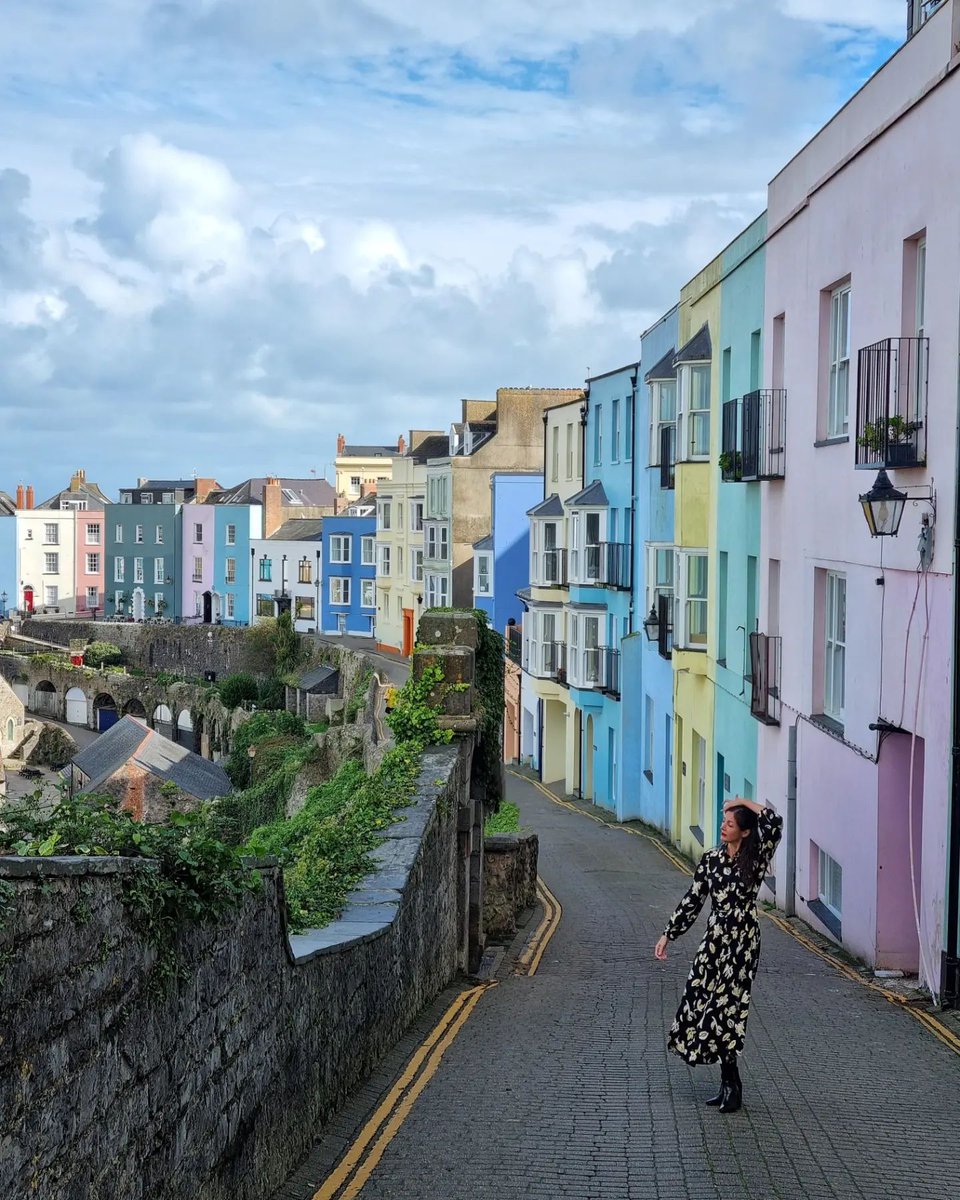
[673,257,722,858]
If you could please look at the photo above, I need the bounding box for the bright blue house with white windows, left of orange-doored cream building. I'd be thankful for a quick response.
[320,512,377,637]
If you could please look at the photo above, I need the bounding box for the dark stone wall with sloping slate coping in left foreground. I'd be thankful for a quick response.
[0,740,470,1200]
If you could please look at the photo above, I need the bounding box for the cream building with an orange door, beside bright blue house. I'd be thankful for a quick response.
[376,430,448,656]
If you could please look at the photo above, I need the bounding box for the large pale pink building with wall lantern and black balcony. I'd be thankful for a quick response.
[758,0,960,992]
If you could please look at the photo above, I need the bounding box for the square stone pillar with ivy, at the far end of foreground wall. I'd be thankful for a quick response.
[413,611,485,972]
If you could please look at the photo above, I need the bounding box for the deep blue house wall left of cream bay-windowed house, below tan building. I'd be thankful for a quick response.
[473,472,544,634]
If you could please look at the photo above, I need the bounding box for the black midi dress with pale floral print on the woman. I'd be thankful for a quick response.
[665,809,784,1066]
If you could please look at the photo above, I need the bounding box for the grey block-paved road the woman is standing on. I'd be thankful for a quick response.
[275,776,960,1200]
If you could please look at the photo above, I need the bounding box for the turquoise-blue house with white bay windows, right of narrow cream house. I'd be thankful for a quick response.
[565,362,640,818]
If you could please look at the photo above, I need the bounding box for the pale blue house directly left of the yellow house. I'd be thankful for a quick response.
[620,307,678,833]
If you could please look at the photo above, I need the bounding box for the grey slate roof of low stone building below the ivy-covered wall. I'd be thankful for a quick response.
[73,716,232,800]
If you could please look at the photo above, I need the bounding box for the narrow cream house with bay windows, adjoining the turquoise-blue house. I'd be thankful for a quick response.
[520,395,586,792]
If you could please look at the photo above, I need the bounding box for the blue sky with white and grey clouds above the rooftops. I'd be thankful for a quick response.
[0,0,906,499]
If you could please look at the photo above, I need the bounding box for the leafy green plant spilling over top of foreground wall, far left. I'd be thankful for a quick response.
[0,796,260,984]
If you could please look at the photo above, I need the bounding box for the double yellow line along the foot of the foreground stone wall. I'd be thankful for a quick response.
[313,980,497,1200]
